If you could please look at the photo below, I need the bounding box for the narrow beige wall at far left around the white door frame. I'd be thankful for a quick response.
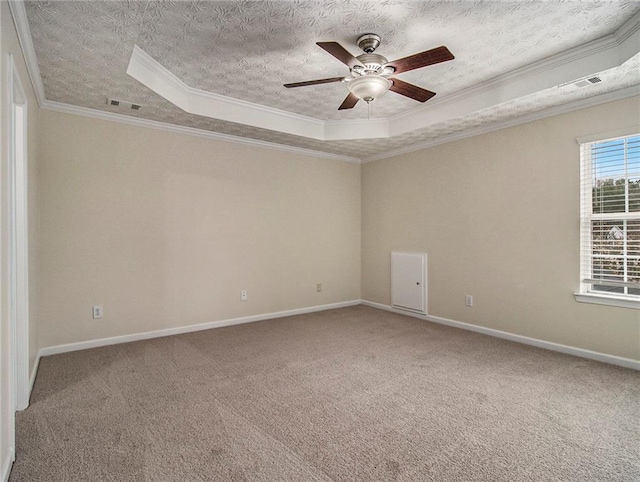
[0,1,39,476]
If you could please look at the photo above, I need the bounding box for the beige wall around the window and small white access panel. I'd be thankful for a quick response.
[362,98,640,359]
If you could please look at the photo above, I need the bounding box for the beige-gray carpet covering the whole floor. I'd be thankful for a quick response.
[10,306,640,482]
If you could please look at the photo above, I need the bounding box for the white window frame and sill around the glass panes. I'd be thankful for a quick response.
[574,127,640,309]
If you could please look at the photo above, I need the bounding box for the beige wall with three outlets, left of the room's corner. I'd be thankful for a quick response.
[39,111,360,347]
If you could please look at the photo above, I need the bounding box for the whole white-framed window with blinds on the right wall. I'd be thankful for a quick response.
[576,134,640,308]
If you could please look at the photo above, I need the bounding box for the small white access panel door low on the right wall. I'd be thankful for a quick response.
[391,252,427,314]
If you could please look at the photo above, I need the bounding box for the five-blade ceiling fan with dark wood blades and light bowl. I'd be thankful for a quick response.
[284,33,455,110]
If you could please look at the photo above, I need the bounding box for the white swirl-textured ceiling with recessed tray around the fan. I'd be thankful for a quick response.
[25,0,640,158]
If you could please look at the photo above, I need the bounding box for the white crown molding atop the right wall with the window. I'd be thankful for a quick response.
[361,85,640,164]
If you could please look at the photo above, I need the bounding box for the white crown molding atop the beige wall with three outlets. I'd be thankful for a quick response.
[41,100,360,164]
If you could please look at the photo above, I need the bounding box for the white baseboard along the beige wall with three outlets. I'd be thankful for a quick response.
[40,300,360,360]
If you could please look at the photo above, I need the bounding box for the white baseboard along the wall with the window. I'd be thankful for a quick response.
[362,300,640,370]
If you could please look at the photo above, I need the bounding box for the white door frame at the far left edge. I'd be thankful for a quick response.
[7,54,31,410]
